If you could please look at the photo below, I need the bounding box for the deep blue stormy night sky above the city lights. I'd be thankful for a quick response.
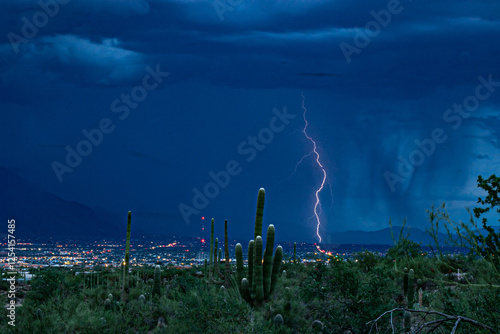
[0,0,500,242]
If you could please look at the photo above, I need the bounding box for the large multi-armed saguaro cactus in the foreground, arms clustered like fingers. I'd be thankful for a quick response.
[235,188,283,307]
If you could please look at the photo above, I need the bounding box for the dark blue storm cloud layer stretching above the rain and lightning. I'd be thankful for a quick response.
[2,0,500,97]
